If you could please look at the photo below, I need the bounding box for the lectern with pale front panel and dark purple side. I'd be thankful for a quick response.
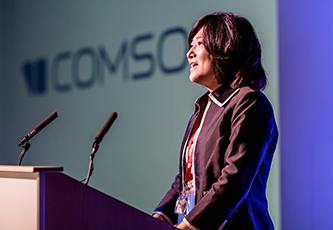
[0,165,176,230]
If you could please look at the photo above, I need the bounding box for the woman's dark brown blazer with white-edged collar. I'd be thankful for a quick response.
[155,87,278,230]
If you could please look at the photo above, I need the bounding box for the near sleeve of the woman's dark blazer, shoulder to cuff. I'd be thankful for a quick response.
[185,91,277,229]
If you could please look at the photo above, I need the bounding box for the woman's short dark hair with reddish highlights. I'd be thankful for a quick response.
[188,12,267,90]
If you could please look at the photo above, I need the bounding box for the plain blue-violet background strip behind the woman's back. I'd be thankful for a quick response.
[278,0,333,229]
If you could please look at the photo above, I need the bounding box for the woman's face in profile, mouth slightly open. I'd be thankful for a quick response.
[186,29,220,92]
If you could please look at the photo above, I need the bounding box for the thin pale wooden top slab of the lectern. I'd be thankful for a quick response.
[0,165,64,173]
